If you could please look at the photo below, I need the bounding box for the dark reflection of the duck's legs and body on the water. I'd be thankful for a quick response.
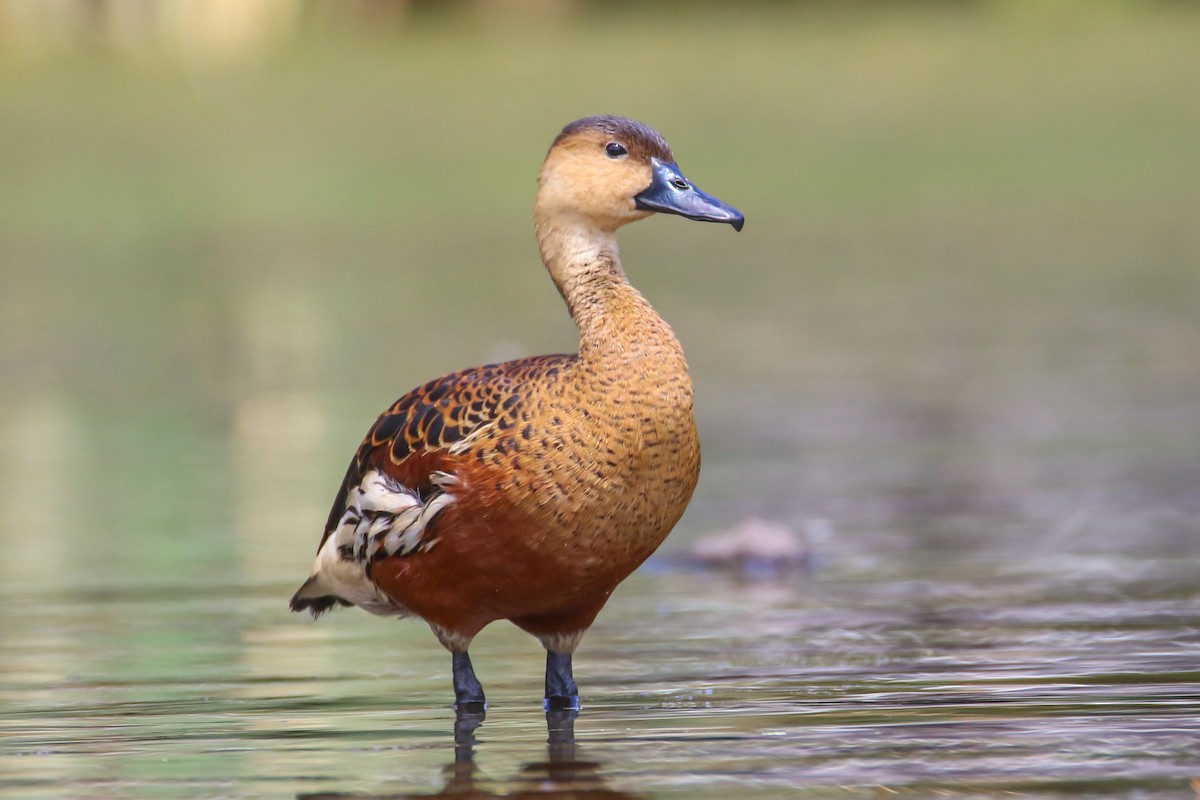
[296,709,642,800]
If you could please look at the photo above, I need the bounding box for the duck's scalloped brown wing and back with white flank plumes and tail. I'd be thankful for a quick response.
[292,355,576,614]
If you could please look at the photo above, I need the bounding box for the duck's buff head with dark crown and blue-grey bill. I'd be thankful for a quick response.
[538,116,745,231]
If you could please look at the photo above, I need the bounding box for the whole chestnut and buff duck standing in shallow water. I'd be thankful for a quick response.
[292,116,744,710]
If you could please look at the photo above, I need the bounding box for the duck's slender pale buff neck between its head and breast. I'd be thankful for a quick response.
[536,215,686,369]
